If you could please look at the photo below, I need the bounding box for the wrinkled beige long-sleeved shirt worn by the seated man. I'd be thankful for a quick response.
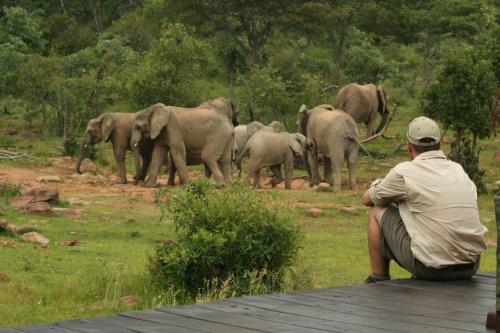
[371,150,488,268]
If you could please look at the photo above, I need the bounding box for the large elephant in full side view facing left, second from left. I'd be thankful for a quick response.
[131,98,238,187]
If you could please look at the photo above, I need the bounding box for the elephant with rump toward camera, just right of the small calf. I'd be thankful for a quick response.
[297,104,360,190]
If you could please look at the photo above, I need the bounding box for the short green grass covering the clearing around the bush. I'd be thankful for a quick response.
[0,104,500,327]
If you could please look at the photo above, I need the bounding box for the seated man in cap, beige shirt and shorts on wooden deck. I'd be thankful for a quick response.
[362,117,487,283]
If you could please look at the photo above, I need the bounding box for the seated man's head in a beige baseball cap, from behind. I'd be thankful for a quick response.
[406,117,441,157]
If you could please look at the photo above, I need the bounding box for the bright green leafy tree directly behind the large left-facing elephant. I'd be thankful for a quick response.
[129,23,213,107]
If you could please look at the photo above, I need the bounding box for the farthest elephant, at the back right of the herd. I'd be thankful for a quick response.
[335,83,389,137]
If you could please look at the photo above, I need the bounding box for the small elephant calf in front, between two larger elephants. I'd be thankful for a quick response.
[240,129,314,189]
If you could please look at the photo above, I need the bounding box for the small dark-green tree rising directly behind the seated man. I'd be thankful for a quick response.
[422,45,496,188]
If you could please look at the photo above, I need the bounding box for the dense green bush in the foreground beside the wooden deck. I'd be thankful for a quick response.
[151,179,301,303]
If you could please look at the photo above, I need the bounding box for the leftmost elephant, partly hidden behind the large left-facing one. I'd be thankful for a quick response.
[76,112,153,184]
